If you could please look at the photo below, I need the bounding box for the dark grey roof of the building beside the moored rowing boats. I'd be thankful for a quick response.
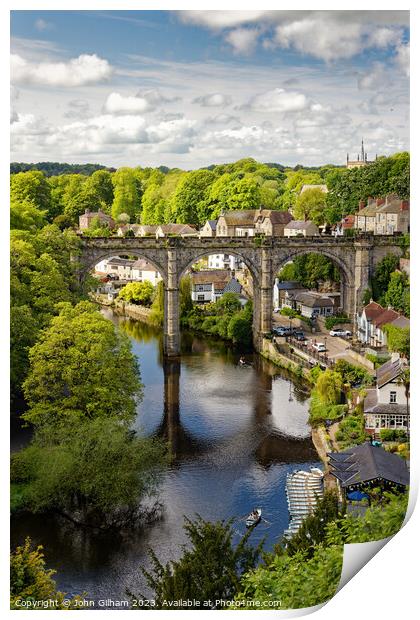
[328,443,410,487]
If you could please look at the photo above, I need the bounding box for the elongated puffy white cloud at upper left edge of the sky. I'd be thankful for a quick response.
[11,54,112,87]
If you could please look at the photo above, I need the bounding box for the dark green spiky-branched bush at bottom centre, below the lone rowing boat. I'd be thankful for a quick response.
[131,516,262,609]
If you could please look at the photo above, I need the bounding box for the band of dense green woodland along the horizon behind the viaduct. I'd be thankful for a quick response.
[11,153,410,229]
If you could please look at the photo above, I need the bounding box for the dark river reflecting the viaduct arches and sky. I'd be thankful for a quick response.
[12,309,319,601]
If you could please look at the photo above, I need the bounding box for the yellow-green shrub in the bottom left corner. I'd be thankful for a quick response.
[10,538,81,610]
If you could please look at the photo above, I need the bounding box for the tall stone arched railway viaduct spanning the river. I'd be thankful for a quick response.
[77,235,402,357]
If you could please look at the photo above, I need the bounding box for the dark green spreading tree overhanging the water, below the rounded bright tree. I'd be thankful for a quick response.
[11,412,166,527]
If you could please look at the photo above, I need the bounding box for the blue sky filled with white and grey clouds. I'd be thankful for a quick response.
[10,10,409,169]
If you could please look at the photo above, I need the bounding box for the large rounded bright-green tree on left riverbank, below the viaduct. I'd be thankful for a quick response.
[23,302,142,426]
